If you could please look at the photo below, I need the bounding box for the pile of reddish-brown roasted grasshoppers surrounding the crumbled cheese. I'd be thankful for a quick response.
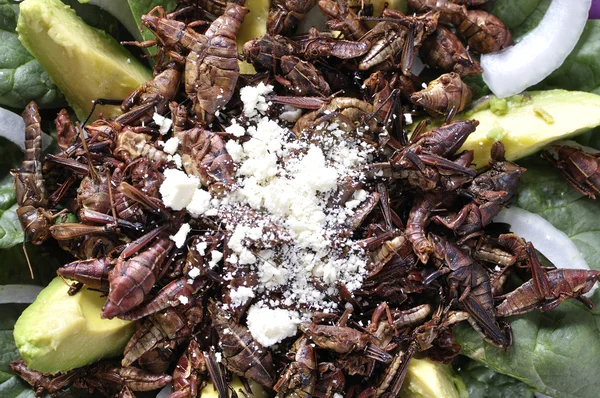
[11,0,600,398]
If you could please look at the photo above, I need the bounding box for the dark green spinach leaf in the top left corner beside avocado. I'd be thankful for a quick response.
[0,0,65,108]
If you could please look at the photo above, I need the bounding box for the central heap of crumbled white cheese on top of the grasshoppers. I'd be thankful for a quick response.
[161,84,376,314]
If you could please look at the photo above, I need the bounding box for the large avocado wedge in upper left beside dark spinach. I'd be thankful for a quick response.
[17,0,152,120]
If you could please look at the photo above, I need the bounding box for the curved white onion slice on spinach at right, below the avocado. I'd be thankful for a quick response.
[494,206,596,296]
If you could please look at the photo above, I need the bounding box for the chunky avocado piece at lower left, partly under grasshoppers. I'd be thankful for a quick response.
[14,277,135,373]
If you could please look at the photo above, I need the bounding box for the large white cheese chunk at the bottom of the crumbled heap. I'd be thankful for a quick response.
[248,305,299,347]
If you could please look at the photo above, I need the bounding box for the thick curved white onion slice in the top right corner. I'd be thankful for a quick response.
[481,0,592,98]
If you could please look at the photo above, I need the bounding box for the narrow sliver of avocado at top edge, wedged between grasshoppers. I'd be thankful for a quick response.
[236,0,271,75]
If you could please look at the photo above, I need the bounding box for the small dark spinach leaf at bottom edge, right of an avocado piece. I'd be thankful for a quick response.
[458,357,533,398]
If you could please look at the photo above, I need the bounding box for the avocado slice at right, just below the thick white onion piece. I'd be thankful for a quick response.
[442,90,600,168]
